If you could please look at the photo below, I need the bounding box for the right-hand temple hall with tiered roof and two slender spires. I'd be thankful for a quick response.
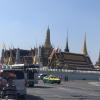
[48,36,94,70]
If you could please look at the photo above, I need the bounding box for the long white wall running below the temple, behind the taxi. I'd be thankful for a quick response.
[40,69,100,80]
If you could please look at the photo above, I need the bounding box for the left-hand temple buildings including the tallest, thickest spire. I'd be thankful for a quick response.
[1,27,53,66]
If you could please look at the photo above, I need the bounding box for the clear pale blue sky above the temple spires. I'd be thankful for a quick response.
[0,0,100,63]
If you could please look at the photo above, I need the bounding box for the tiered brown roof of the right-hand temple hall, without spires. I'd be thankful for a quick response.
[49,52,93,69]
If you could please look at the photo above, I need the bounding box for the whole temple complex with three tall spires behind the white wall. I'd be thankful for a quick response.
[1,27,94,70]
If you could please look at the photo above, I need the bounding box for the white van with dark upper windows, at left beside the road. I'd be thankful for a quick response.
[3,69,26,97]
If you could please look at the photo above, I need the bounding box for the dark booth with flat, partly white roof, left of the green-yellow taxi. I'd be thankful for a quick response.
[12,64,40,87]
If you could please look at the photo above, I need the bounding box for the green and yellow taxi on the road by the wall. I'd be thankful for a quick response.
[43,75,61,84]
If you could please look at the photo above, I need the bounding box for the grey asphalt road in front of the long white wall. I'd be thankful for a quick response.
[27,80,100,100]
